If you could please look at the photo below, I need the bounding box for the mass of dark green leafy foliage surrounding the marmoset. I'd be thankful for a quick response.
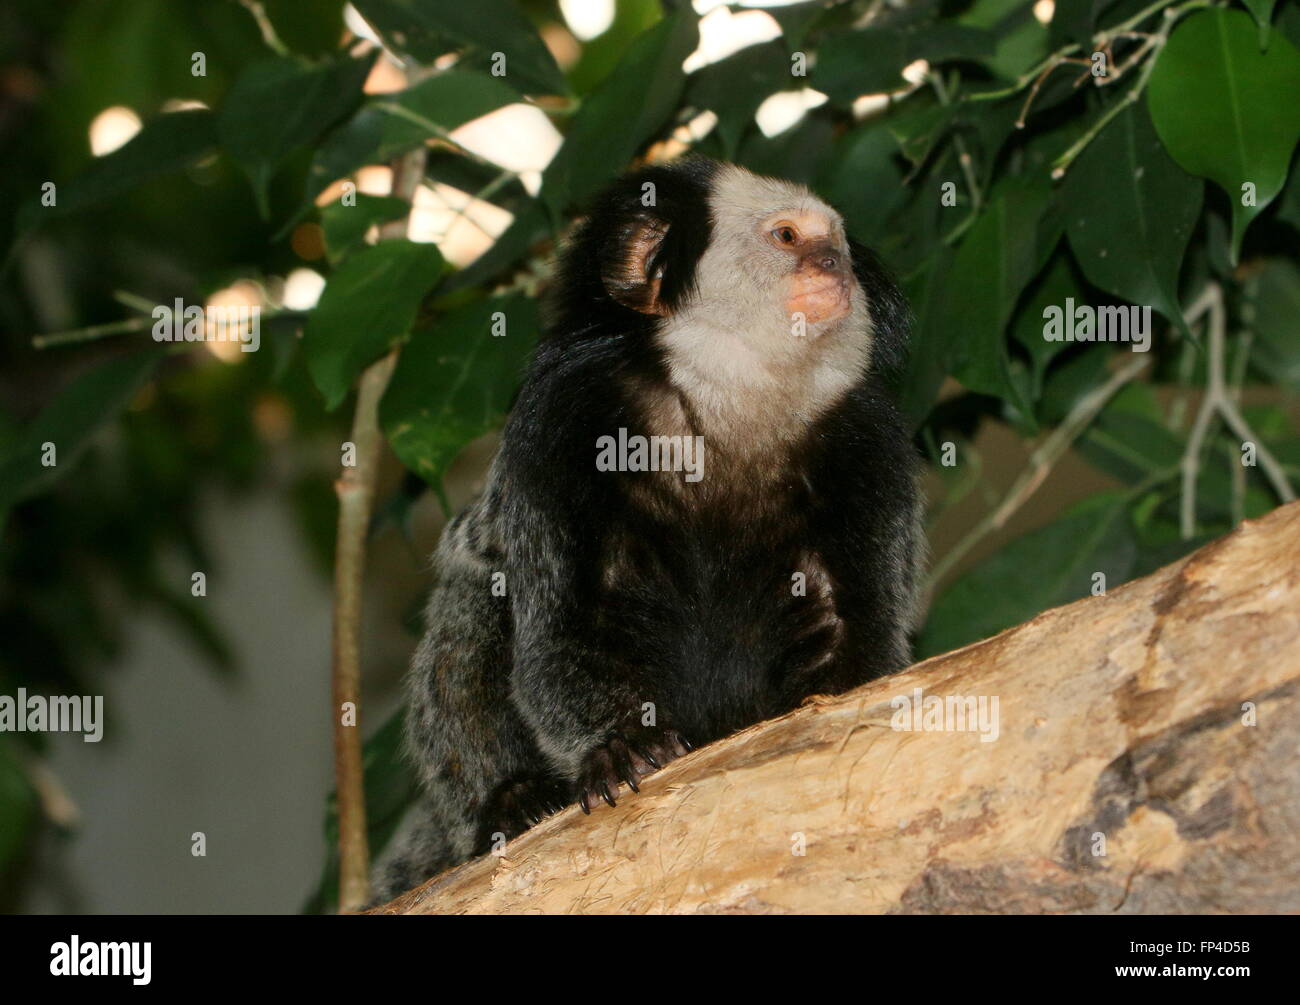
[0,0,1300,909]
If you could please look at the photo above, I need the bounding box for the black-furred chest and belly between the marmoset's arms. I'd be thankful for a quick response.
[595,481,840,737]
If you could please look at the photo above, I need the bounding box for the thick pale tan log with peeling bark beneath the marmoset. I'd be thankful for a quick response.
[381,503,1300,914]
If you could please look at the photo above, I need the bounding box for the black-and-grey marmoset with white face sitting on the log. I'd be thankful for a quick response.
[376,159,924,900]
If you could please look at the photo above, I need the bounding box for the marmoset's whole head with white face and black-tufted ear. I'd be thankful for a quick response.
[592,161,884,421]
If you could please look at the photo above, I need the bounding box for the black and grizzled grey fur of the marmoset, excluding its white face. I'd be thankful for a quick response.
[377,161,923,897]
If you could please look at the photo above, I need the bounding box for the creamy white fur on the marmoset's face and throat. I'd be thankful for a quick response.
[659,165,871,447]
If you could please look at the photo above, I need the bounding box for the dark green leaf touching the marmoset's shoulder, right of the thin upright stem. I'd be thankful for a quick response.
[380,293,540,490]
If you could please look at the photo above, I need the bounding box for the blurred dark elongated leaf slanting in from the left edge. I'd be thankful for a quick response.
[0,348,161,520]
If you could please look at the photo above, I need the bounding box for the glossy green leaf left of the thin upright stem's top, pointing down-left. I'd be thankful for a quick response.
[303,241,443,410]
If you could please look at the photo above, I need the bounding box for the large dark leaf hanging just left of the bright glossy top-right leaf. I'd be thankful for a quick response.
[1062,105,1204,330]
